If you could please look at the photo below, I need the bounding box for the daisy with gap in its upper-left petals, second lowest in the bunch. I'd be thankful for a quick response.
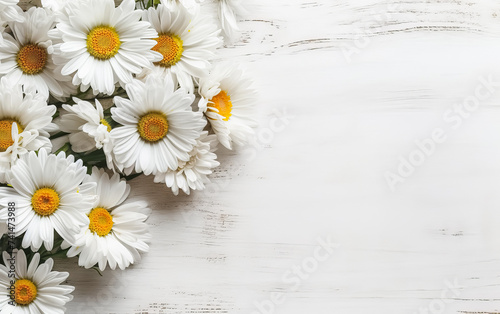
[63,167,151,271]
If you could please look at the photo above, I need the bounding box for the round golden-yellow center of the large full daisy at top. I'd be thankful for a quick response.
[87,26,121,60]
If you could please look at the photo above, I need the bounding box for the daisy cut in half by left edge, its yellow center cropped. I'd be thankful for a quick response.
[0,77,57,183]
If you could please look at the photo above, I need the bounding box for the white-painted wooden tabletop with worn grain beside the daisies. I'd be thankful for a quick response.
[50,0,500,314]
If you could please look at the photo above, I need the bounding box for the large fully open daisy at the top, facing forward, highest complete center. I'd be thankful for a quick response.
[50,0,161,95]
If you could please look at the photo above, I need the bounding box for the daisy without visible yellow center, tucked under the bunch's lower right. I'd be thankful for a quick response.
[155,131,219,195]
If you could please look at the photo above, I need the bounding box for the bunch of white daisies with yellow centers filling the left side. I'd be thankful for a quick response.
[0,0,255,314]
